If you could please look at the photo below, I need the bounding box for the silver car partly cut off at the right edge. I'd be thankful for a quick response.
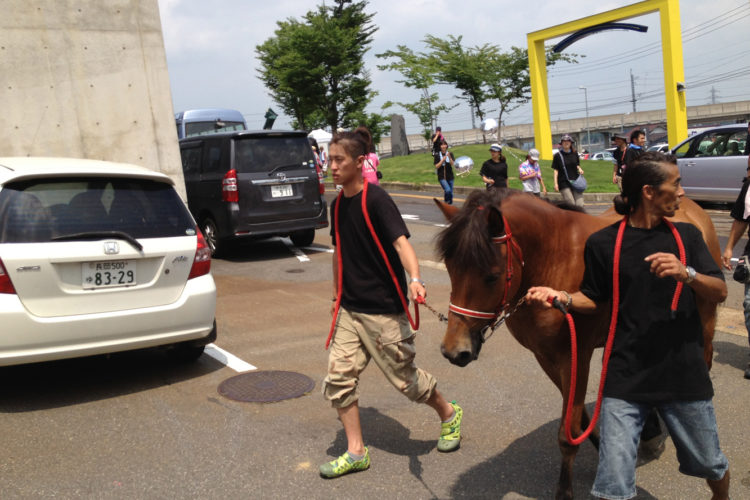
[672,124,748,203]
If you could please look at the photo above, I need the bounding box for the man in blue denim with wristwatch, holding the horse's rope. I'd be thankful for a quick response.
[526,153,729,500]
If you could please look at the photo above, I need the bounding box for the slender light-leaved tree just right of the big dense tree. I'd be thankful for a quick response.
[376,45,455,141]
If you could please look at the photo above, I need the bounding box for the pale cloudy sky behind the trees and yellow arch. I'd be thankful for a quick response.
[158,0,750,134]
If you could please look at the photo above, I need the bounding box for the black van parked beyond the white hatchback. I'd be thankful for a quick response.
[180,130,328,254]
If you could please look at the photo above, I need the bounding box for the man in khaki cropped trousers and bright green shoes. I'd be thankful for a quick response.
[320,127,463,478]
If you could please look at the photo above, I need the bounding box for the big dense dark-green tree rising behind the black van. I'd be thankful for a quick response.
[255,0,377,131]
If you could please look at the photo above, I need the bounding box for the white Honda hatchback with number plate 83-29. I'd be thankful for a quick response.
[0,158,216,366]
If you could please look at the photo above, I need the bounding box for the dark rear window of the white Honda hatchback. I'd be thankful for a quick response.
[0,177,195,243]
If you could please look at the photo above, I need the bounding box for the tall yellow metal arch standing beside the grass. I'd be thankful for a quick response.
[526,0,687,160]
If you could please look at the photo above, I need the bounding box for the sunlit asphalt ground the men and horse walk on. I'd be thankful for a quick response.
[0,191,750,499]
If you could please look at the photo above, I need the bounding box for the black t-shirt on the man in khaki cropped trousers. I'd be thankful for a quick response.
[331,184,410,314]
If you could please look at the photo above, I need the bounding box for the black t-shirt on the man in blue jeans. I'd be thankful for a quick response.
[581,221,724,403]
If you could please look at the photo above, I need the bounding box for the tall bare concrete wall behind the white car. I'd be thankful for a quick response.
[0,0,184,198]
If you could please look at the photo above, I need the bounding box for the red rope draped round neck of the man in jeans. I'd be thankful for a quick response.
[565,216,687,446]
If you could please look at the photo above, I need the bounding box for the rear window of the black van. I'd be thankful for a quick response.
[234,136,314,173]
